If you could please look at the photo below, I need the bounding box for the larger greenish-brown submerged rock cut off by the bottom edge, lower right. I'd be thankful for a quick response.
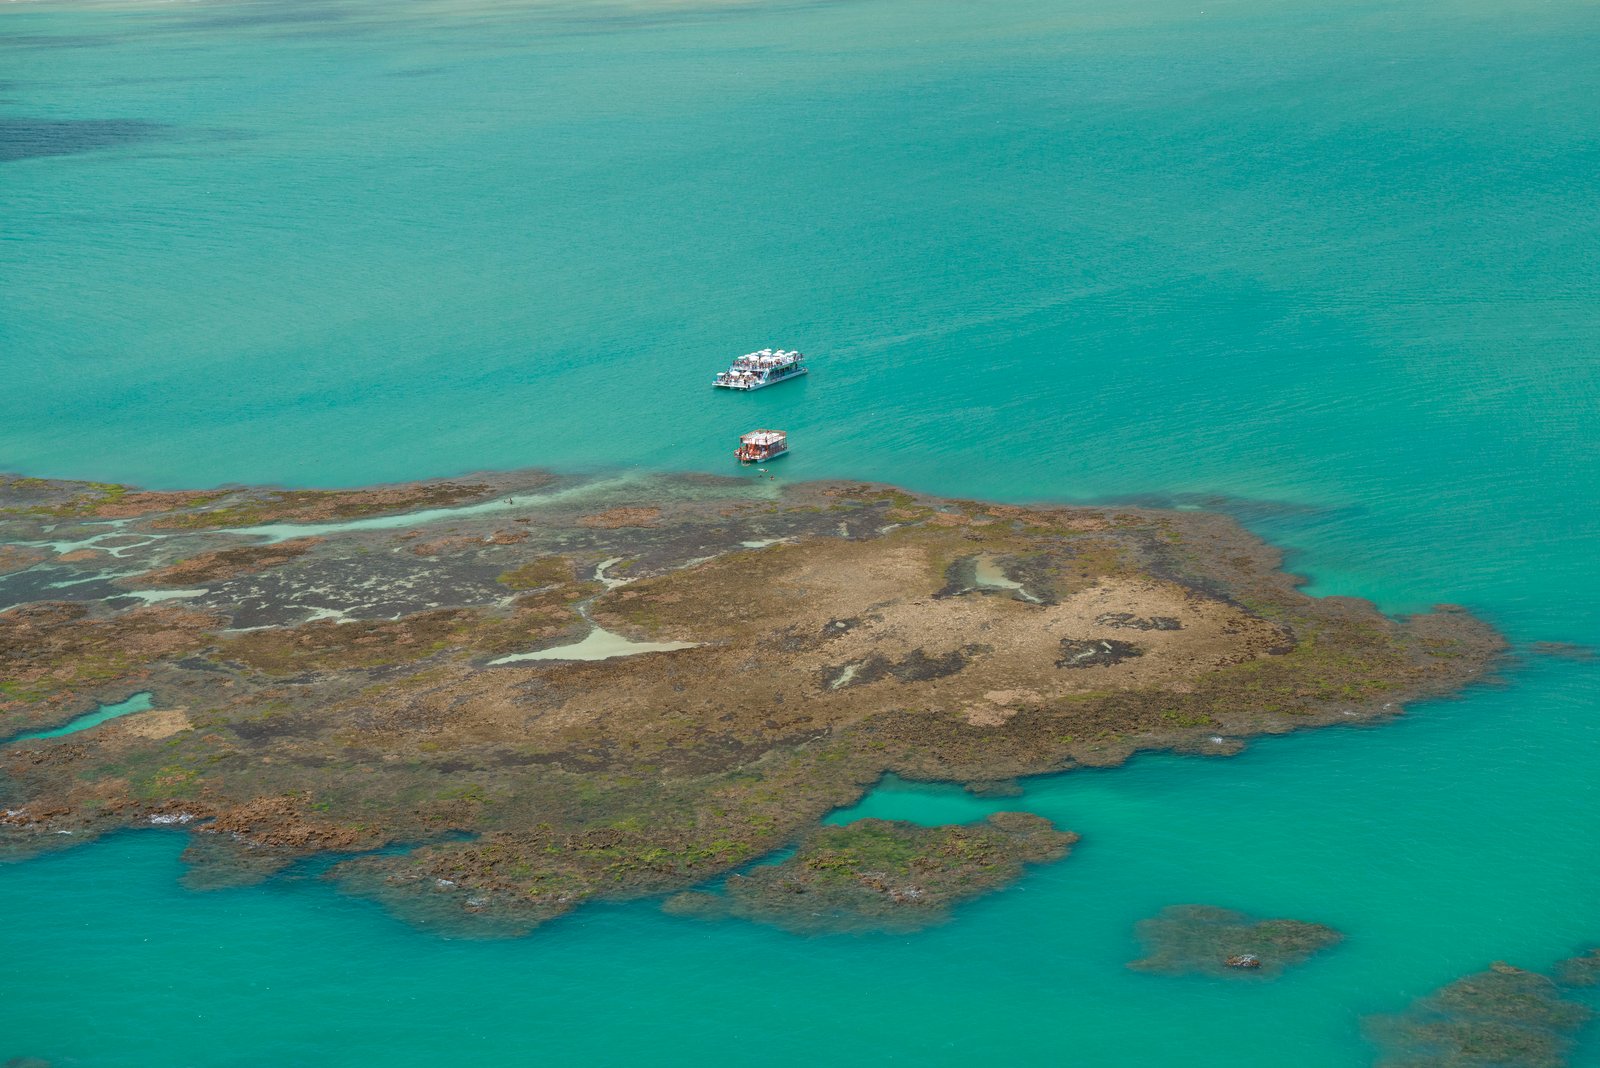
[1368,961,1589,1068]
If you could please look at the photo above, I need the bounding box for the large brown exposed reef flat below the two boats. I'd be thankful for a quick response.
[0,473,1502,929]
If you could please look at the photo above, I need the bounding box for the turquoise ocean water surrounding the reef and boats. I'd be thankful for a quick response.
[0,0,1600,1068]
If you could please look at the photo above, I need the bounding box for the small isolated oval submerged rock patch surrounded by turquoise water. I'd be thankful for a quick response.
[1128,905,1342,975]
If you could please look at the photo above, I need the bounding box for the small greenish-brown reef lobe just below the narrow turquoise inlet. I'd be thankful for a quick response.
[667,812,1078,934]
